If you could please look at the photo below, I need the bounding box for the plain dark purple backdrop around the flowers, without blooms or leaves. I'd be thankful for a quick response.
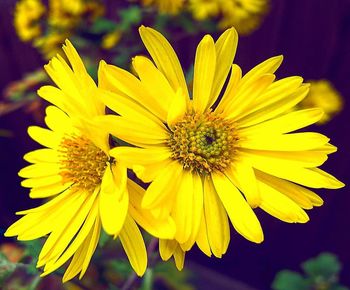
[0,0,350,290]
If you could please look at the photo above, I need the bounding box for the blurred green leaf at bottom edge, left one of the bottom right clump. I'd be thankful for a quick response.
[272,270,310,290]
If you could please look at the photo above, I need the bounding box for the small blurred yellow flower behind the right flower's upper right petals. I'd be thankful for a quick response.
[299,80,343,124]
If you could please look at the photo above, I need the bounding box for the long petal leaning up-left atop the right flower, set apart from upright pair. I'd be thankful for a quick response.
[139,26,189,99]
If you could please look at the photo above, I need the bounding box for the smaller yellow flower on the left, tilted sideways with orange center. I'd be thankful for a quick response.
[5,41,175,281]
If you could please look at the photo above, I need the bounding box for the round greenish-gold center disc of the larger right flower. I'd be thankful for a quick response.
[168,112,238,174]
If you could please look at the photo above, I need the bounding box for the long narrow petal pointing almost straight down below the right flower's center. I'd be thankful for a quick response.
[203,178,230,258]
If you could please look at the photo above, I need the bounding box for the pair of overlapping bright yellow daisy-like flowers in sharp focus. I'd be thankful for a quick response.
[6,26,344,281]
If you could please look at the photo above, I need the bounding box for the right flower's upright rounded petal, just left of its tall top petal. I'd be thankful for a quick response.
[193,35,216,113]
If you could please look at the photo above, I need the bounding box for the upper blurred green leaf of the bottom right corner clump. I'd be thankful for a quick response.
[302,253,341,280]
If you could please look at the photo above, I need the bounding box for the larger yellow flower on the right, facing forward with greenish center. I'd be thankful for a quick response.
[99,26,343,268]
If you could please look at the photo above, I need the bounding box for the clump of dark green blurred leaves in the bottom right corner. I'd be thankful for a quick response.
[272,253,349,290]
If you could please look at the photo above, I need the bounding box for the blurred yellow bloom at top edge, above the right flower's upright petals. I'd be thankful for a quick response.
[189,0,269,34]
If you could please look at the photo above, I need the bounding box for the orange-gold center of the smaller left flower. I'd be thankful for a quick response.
[59,136,108,192]
